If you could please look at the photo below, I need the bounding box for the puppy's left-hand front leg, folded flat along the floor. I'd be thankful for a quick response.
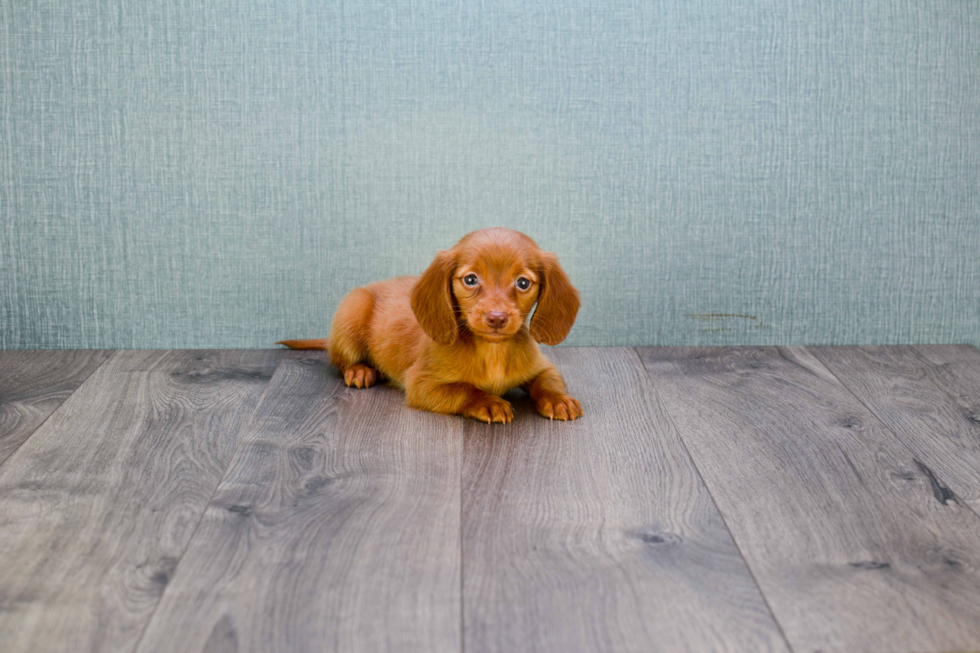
[405,370,514,424]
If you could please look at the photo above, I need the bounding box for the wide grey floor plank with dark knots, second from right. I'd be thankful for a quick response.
[641,348,980,651]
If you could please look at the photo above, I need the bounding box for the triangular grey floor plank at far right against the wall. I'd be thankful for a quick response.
[810,345,980,513]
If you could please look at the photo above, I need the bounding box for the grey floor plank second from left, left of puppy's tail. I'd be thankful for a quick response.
[0,350,281,653]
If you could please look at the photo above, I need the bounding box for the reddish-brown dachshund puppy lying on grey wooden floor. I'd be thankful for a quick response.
[279,228,582,423]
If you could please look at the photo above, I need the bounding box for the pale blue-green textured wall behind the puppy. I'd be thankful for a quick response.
[0,0,980,348]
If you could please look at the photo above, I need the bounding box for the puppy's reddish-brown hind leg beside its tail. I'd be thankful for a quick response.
[328,288,378,388]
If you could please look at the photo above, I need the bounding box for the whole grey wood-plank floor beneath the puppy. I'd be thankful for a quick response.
[0,346,980,653]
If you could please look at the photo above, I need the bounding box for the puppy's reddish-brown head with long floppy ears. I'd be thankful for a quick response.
[412,227,579,345]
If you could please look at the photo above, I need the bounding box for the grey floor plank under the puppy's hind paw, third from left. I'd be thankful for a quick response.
[139,352,462,653]
